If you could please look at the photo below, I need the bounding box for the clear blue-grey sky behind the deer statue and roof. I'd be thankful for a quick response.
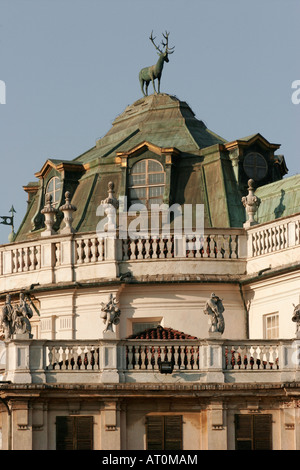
[0,0,300,243]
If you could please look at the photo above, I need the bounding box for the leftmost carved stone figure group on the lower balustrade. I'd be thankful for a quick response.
[1,293,33,340]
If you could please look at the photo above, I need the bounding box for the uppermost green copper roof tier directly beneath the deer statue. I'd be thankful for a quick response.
[75,93,226,163]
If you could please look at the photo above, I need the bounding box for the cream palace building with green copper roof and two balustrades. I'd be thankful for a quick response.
[0,93,300,450]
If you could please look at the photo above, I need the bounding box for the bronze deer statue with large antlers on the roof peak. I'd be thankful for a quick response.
[139,31,175,96]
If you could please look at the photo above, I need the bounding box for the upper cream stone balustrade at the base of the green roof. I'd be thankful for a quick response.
[0,214,300,292]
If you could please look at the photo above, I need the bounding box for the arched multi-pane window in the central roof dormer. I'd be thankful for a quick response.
[129,159,165,209]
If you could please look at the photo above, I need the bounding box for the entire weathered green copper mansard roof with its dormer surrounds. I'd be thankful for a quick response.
[16,93,286,241]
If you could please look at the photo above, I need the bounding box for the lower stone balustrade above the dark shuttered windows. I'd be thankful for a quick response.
[3,337,300,383]
